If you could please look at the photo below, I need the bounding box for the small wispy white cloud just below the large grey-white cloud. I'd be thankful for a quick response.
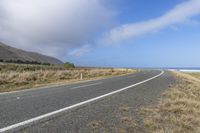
[69,45,91,57]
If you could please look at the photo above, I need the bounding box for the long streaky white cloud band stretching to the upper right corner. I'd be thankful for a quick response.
[102,0,200,44]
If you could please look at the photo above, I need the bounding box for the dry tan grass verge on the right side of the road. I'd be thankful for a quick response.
[140,72,200,133]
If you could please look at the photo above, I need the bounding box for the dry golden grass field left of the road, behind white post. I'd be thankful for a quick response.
[0,63,135,92]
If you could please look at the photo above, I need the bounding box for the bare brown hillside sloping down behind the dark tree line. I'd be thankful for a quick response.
[0,42,63,64]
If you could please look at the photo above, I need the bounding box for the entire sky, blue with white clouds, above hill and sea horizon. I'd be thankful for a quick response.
[0,0,200,67]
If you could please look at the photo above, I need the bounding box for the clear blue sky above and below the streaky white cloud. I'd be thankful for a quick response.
[68,0,200,67]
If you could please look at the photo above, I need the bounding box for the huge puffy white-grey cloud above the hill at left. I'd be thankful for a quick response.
[0,0,113,56]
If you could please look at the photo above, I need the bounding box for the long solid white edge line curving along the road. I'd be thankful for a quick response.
[0,71,164,133]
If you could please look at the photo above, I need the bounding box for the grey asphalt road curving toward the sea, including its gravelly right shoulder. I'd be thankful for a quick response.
[0,70,174,133]
